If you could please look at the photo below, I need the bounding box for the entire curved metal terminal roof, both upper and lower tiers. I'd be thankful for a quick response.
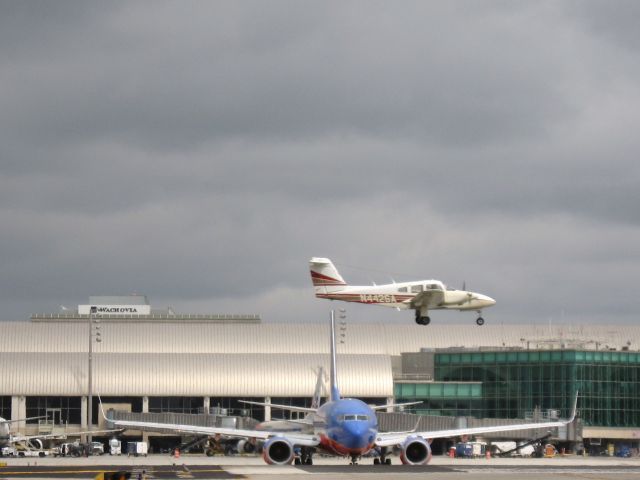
[0,321,640,397]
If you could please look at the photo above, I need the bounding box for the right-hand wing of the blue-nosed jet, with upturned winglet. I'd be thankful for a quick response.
[376,395,578,447]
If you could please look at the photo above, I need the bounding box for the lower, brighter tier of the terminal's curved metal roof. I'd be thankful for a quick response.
[0,353,393,397]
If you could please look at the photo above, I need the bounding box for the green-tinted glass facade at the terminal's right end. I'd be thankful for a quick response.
[396,350,640,427]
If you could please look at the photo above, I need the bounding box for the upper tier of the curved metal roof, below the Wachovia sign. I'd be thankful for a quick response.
[0,321,640,355]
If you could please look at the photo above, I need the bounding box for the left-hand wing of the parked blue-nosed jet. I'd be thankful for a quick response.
[106,418,320,447]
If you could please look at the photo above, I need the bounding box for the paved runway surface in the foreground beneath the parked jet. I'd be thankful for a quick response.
[0,456,640,480]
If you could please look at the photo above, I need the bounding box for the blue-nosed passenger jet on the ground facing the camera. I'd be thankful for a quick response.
[101,312,577,465]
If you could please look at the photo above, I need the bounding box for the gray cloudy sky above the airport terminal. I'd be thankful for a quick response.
[0,0,640,324]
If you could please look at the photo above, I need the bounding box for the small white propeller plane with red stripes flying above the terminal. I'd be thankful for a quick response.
[309,257,496,325]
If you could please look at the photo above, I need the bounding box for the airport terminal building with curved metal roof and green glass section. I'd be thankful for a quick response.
[0,296,640,454]
